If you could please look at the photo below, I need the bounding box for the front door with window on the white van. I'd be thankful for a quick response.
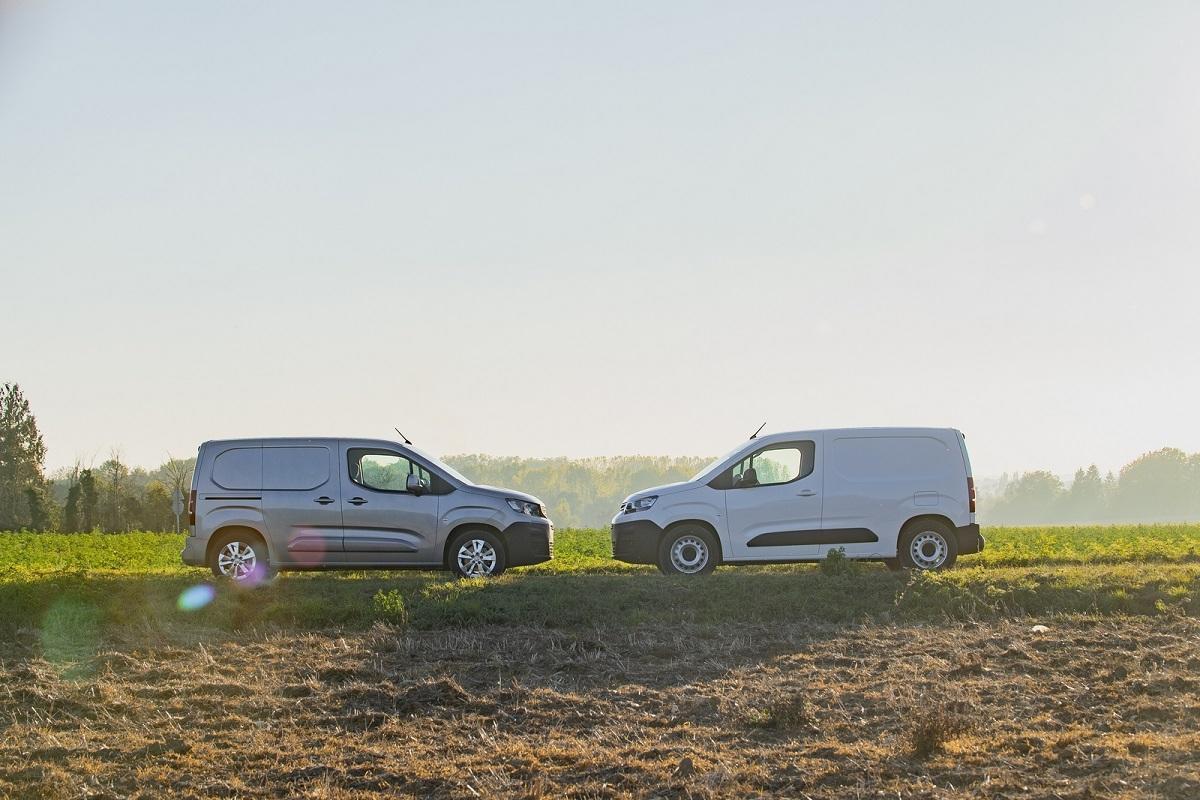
[716,439,822,561]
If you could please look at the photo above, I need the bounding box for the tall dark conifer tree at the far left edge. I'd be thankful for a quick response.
[0,384,46,530]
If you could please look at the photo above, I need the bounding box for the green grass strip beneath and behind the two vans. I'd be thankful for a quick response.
[0,525,1200,630]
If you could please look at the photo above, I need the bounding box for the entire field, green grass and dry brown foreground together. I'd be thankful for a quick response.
[0,525,1200,800]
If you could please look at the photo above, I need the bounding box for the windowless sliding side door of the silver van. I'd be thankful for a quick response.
[263,439,342,567]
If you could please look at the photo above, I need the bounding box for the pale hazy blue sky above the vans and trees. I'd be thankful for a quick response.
[0,0,1200,475]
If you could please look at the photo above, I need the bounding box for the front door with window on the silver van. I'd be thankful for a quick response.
[340,441,442,566]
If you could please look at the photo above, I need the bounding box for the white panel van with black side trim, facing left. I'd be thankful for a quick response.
[612,428,984,575]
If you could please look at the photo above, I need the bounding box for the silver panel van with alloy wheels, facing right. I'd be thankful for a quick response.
[182,439,554,582]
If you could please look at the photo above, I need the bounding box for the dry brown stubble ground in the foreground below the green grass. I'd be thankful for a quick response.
[0,618,1200,798]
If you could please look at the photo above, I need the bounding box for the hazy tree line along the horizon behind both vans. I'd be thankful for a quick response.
[0,384,1200,533]
